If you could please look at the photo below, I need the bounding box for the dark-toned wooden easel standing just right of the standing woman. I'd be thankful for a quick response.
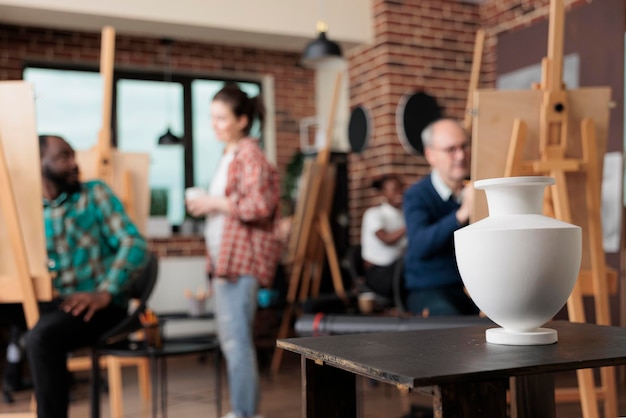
[271,73,348,373]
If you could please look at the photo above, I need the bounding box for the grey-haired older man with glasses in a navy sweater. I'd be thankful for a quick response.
[404,119,478,315]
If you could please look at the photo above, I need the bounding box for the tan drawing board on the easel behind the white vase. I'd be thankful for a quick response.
[471,87,611,268]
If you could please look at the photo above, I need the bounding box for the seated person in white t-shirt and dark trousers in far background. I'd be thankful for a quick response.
[361,175,407,299]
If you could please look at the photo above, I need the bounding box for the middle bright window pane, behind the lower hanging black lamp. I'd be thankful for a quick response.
[117,79,185,225]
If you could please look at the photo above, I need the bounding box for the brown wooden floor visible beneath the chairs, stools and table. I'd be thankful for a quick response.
[0,353,626,418]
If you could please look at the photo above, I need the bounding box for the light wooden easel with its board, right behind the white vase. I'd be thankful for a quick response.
[472,0,617,418]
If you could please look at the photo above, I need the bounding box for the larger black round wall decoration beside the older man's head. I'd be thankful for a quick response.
[396,91,441,155]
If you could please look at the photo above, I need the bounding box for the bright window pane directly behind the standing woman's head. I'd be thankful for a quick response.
[191,80,261,188]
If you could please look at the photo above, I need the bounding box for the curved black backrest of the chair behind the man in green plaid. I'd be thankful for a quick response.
[99,253,159,345]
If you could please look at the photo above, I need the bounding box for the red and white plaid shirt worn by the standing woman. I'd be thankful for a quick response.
[209,138,281,287]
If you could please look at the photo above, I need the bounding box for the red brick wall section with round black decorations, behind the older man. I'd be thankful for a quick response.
[349,0,480,243]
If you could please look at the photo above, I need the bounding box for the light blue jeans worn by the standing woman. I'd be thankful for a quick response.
[213,276,259,417]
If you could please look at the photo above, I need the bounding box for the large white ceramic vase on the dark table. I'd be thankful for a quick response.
[454,176,582,345]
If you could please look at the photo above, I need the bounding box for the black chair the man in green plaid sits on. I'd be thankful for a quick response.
[91,254,159,418]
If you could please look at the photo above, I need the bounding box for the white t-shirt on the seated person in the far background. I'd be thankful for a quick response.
[361,203,407,266]
